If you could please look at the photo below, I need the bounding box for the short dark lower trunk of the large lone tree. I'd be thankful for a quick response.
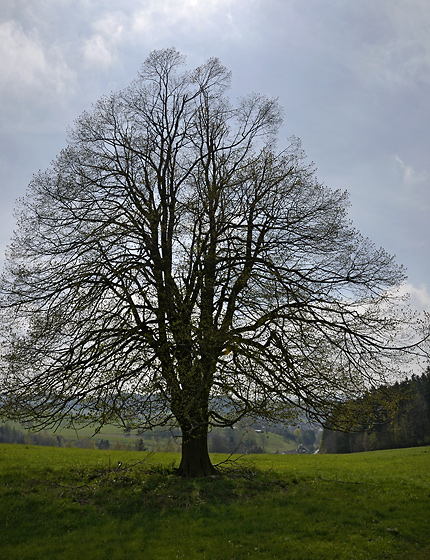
[177,426,219,478]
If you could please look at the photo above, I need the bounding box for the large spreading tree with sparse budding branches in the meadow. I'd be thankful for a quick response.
[0,49,426,476]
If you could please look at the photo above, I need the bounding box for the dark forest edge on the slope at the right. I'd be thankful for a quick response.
[320,367,430,453]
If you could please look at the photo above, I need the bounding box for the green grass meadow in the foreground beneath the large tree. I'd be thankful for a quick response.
[0,445,430,560]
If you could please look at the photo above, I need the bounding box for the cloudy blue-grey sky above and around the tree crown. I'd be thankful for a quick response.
[0,0,430,310]
